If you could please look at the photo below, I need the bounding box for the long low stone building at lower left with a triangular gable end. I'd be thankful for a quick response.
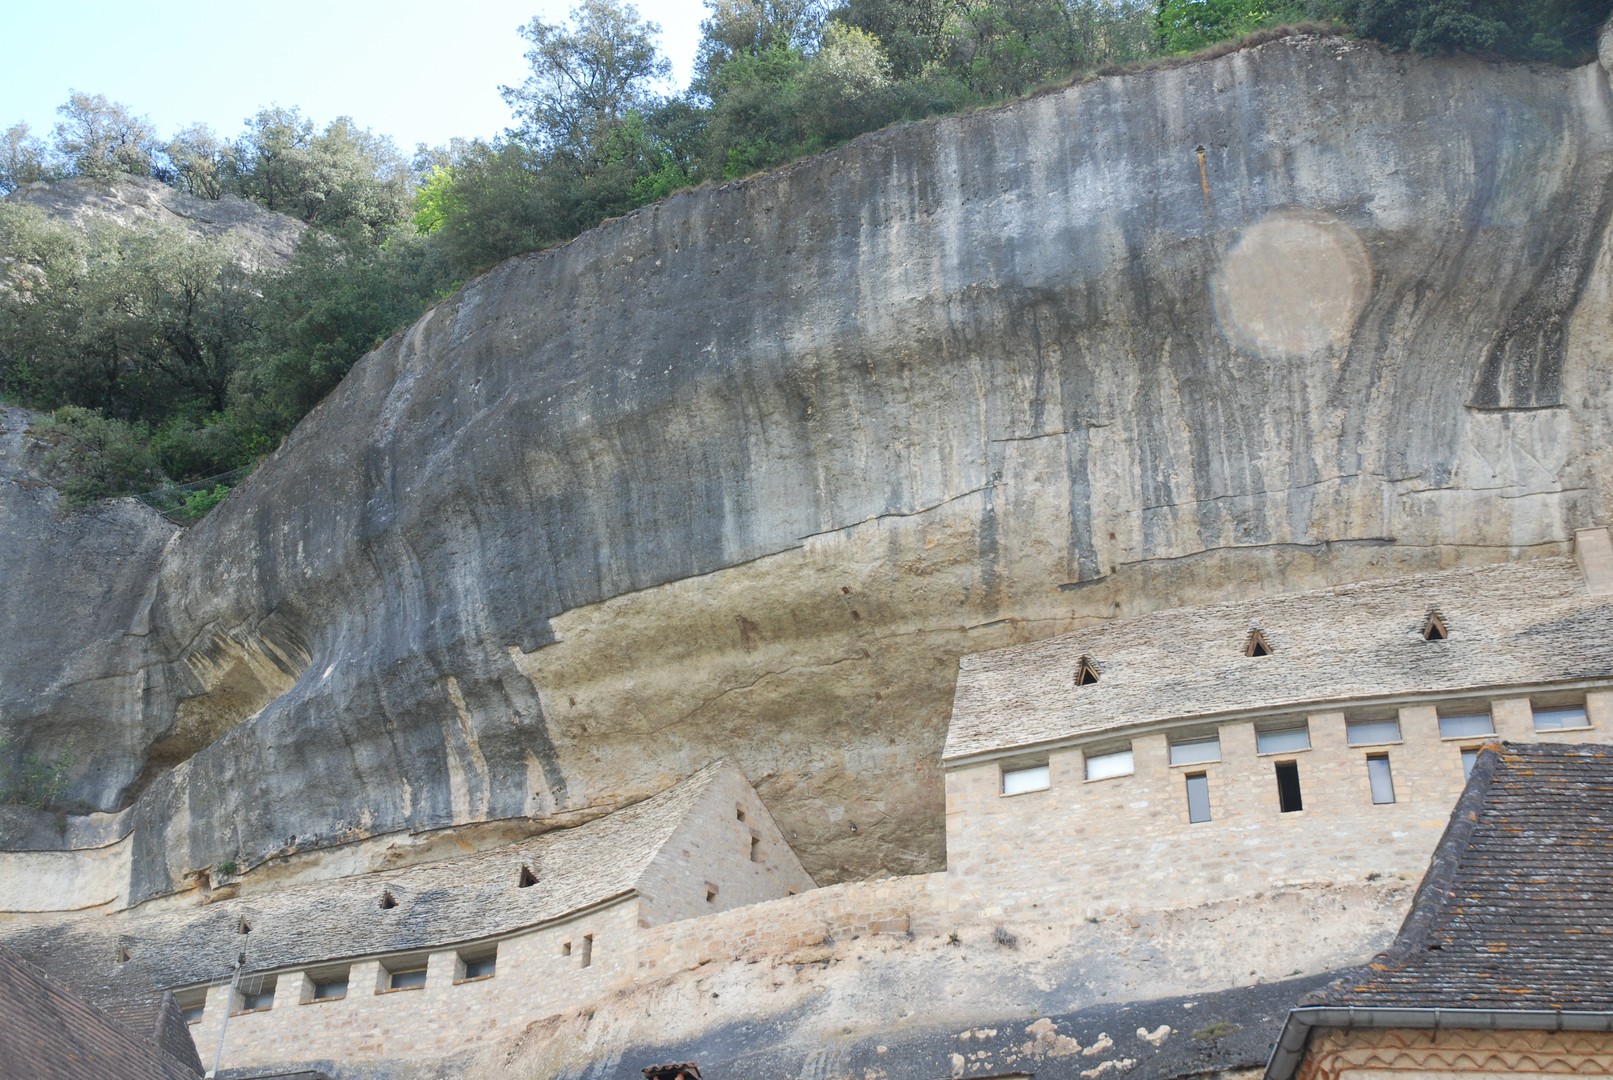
[0,762,813,1067]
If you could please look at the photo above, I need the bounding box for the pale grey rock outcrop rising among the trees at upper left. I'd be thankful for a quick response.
[6,176,306,268]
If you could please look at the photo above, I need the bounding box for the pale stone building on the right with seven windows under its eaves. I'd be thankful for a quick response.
[944,529,1613,914]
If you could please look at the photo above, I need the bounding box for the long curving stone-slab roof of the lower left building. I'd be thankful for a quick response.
[6,762,732,1001]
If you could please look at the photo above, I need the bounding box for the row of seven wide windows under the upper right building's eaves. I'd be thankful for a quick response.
[1002,704,1590,801]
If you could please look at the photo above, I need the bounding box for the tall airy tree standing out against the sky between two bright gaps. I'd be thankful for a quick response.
[498,0,671,156]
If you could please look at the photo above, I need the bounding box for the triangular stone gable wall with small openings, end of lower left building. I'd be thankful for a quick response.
[639,771,813,924]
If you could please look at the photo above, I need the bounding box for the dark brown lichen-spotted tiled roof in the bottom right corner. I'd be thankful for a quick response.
[1302,743,1613,1011]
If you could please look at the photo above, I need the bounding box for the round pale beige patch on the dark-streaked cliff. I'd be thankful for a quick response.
[1215,211,1373,358]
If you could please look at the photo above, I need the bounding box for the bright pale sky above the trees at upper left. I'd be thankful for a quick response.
[0,0,705,153]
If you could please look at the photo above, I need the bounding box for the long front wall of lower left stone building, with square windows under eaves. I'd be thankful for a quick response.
[181,899,639,1069]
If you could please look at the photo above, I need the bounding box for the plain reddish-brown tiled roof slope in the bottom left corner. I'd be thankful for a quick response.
[0,946,202,1080]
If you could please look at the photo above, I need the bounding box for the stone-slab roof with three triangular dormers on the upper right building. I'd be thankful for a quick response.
[945,558,1613,759]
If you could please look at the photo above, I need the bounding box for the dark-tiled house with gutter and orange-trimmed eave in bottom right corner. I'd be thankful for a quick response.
[1266,743,1613,1080]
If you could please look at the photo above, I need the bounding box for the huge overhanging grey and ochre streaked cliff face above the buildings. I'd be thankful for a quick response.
[0,31,1613,898]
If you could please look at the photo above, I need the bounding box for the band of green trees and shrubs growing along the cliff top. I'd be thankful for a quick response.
[0,0,1613,509]
